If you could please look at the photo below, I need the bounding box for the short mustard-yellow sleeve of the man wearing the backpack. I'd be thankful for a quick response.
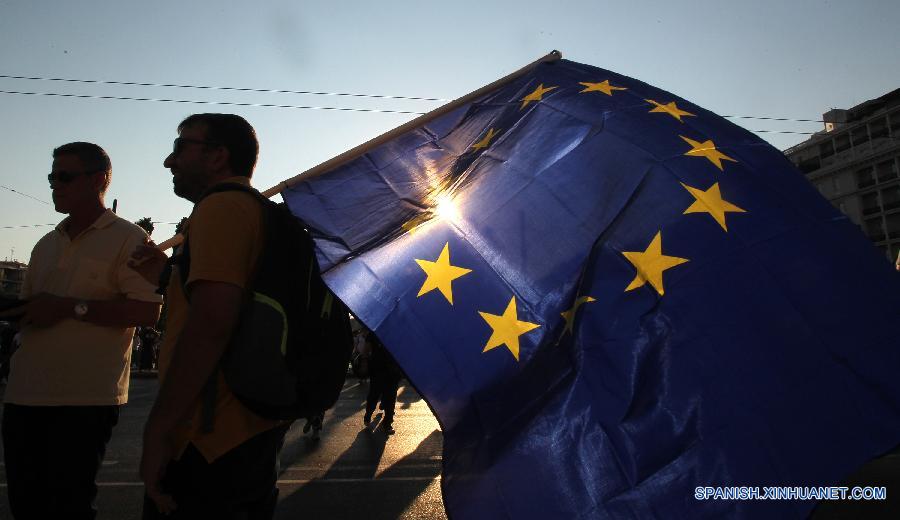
[186,192,261,289]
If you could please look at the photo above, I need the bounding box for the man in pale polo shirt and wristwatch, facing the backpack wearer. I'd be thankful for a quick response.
[3,142,161,518]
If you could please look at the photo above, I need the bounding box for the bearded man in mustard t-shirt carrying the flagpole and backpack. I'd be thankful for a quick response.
[133,114,285,520]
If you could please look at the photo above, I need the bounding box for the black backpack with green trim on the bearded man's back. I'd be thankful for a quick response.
[172,183,353,431]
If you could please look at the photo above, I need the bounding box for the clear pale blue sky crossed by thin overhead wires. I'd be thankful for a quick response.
[0,0,900,262]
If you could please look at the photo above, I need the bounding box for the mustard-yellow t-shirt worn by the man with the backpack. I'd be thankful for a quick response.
[159,177,281,462]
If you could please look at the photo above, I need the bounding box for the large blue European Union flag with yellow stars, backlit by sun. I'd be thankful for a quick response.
[282,60,900,519]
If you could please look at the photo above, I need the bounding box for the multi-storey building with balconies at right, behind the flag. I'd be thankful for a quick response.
[784,89,900,261]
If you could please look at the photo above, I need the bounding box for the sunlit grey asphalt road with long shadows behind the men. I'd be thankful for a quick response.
[0,377,446,520]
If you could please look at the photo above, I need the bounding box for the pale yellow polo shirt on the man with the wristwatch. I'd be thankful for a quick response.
[4,210,162,406]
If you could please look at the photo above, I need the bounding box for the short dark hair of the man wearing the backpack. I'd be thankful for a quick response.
[178,114,259,178]
